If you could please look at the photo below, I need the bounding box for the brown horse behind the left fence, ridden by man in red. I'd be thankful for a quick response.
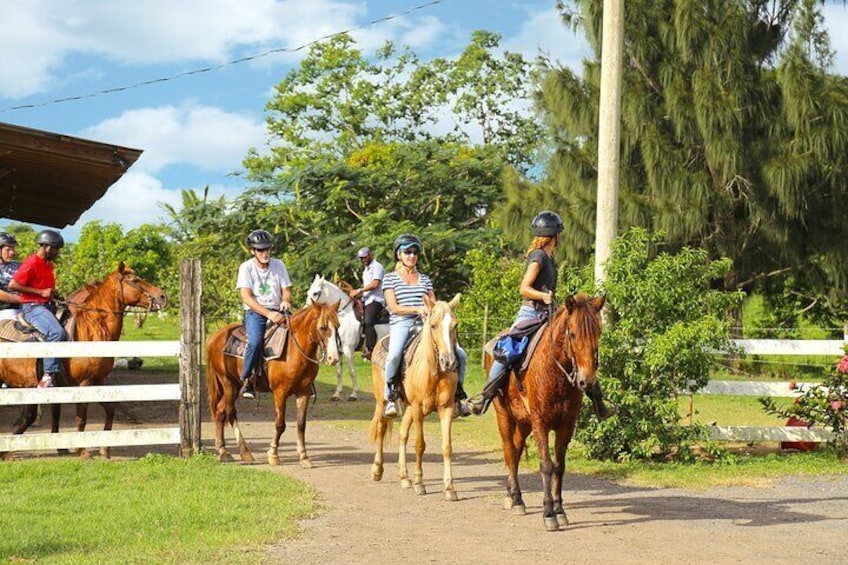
[0,261,166,457]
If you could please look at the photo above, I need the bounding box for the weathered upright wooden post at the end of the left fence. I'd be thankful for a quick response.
[180,259,203,457]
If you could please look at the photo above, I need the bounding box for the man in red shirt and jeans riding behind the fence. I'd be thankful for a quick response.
[9,230,68,388]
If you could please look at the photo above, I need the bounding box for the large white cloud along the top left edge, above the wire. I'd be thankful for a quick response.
[0,0,448,98]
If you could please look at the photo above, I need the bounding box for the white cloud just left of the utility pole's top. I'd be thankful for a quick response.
[502,8,591,71]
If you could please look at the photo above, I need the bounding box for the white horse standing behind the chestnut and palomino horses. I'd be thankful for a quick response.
[306,275,389,401]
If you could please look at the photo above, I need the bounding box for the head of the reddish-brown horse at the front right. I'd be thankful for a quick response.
[554,293,606,390]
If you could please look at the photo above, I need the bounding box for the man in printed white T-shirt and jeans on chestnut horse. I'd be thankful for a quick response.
[236,230,291,398]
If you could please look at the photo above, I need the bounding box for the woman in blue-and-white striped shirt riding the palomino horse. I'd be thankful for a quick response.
[383,233,470,418]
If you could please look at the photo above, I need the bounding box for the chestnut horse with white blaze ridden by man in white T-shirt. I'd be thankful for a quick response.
[206,304,339,467]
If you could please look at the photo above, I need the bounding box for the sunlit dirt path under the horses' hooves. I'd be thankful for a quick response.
[222,412,848,565]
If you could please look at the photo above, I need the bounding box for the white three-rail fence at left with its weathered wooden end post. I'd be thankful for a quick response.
[0,259,202,456]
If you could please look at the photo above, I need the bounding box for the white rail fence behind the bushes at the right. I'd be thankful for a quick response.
[689,339,845,442]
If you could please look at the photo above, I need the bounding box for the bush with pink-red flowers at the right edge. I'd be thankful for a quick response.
[760,346,848,457]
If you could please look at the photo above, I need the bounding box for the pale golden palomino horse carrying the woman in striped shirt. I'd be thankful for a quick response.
[370,294,460,501]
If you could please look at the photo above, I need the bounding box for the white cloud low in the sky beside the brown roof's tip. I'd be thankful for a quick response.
[81,102,266,173]
